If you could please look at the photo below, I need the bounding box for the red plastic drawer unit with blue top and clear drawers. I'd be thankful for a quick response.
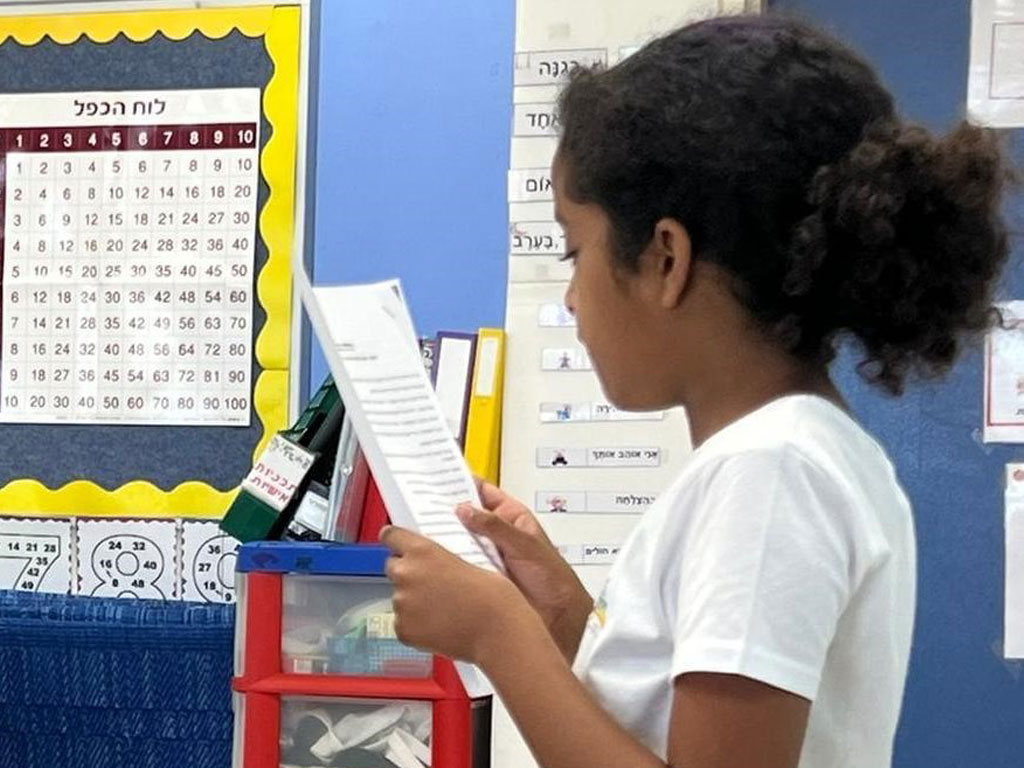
[232,542,490,768]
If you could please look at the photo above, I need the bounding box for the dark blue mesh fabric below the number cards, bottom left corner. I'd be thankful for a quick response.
[0,591,234,768]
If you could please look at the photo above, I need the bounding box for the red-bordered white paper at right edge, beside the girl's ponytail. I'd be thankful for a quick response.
[983,301,1024,442]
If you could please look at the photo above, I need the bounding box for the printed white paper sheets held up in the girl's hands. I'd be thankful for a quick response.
[298,275,500,569]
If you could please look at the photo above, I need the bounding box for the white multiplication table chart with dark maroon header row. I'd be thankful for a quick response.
[0,88,261,426]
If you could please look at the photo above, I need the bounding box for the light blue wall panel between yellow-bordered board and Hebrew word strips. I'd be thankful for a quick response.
[312,0,515,368]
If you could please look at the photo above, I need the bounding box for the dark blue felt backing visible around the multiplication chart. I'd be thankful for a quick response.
[0,31,273,493]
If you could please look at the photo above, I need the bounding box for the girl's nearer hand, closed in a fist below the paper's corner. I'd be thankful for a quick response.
[381,525,537,664]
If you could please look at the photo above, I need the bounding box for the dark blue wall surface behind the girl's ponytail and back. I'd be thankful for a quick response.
[773,0,1024,768]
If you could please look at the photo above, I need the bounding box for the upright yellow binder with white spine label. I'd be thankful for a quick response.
[465,328,505,484]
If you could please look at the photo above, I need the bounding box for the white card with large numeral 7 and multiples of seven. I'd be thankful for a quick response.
[0,517,73,594]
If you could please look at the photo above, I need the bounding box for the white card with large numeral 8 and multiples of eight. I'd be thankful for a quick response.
[78,518,179,600]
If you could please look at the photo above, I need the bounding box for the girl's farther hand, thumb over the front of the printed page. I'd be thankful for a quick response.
[456,480,594,660]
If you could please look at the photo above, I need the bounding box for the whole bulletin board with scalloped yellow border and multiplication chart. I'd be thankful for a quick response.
[0,5,301,517]
